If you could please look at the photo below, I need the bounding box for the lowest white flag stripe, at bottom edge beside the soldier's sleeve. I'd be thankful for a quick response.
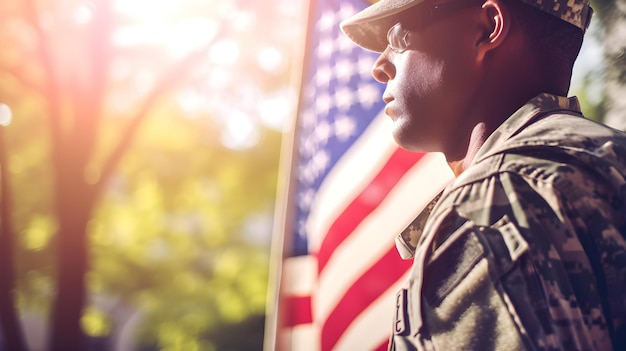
[333,272,410,351]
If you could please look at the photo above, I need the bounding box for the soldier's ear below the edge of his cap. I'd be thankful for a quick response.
[476,0,511,62]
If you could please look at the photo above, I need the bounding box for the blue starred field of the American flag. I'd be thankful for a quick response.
[296,2,383,228]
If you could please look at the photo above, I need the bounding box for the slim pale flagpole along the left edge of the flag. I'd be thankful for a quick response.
[263,0,316,351]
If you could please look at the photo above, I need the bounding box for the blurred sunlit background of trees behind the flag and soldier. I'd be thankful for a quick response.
[0,0,606,351]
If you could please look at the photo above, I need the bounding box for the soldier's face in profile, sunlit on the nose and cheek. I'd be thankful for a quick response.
[372,2,478,152]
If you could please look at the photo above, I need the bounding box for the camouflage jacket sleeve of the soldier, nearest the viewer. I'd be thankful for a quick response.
[394,169,612,350]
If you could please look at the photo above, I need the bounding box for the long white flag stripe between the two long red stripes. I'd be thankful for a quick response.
[312,154,452,320]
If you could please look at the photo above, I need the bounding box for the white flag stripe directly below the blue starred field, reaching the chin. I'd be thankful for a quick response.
[307,112,398,252]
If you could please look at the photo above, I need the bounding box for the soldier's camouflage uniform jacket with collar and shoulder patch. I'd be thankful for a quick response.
[390,94,626,351]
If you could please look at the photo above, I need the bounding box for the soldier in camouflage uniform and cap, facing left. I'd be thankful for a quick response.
[341,0,626,351]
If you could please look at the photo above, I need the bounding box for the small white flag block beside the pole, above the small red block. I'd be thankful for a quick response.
[281,255,317,296]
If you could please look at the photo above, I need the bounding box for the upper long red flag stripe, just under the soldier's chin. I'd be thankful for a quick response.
[317,148,424,273]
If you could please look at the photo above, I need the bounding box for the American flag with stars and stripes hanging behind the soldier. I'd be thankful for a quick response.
[266,0,451,351]
